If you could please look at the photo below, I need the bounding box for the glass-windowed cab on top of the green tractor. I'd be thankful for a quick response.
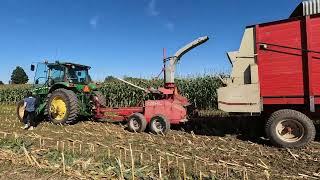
[31,61,92,86]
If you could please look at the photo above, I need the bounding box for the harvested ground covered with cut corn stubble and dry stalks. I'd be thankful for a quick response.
[0,106,320,179]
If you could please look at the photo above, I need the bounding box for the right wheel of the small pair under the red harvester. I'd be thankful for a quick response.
[149,115,170,134]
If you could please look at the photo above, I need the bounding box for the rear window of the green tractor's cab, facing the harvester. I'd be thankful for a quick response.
[68,66,91,84]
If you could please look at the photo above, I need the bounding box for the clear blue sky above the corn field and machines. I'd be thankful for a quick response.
[0,0,301,82]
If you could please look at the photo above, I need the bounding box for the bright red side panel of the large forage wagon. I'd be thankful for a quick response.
[255,15,320,112]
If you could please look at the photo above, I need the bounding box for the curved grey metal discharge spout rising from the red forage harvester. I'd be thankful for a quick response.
[165,36,209,84]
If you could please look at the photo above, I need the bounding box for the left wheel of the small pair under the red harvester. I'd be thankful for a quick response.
[128,113,147,133]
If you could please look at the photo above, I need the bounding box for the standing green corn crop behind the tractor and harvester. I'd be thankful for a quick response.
[0,75,221,109]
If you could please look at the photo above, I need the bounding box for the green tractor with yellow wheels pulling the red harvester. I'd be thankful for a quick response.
[17,61,106,124]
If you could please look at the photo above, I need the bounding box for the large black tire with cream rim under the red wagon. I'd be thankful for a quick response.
[265,109,316,148]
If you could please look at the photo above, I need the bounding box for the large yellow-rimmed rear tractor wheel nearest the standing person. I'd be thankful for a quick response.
[47,89,79,124]
